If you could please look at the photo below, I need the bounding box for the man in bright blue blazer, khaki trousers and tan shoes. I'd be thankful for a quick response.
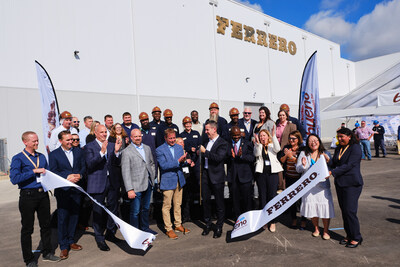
[156,128,190,239]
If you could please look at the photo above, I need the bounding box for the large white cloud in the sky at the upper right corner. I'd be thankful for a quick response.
[305,0,400,60]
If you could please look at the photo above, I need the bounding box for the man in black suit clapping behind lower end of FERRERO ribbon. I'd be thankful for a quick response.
[227,126,255,219]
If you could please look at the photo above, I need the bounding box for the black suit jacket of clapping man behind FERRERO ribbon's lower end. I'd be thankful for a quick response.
[226,138,255,183]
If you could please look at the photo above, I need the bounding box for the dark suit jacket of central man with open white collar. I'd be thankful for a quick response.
[202,136,229,184]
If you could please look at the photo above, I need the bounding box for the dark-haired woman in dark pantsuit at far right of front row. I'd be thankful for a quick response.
[329,128,364,248]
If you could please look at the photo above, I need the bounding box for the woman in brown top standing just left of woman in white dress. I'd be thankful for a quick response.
[278,131,307,230]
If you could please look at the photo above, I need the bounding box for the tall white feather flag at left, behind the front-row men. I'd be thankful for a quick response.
[35,61,60,155]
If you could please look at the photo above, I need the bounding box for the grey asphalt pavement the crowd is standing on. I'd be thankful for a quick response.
[0,154,400,267]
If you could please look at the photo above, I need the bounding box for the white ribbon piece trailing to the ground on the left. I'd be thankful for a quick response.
[38,170,156,250]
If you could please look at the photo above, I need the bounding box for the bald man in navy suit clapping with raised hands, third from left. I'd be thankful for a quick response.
[84,125,122,251]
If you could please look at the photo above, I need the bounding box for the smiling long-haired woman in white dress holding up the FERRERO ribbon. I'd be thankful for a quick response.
[296,134,335,240]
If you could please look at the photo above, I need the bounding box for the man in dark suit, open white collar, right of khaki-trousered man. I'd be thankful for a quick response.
[200,121,228,238]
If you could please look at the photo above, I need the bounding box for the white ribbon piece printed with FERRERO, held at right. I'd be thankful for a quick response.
[231,155,329,238]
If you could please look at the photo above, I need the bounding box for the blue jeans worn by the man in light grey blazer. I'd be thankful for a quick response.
[129,182,153,231]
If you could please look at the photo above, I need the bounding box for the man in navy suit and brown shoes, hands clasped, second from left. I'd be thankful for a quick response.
[49,131,86,260]
